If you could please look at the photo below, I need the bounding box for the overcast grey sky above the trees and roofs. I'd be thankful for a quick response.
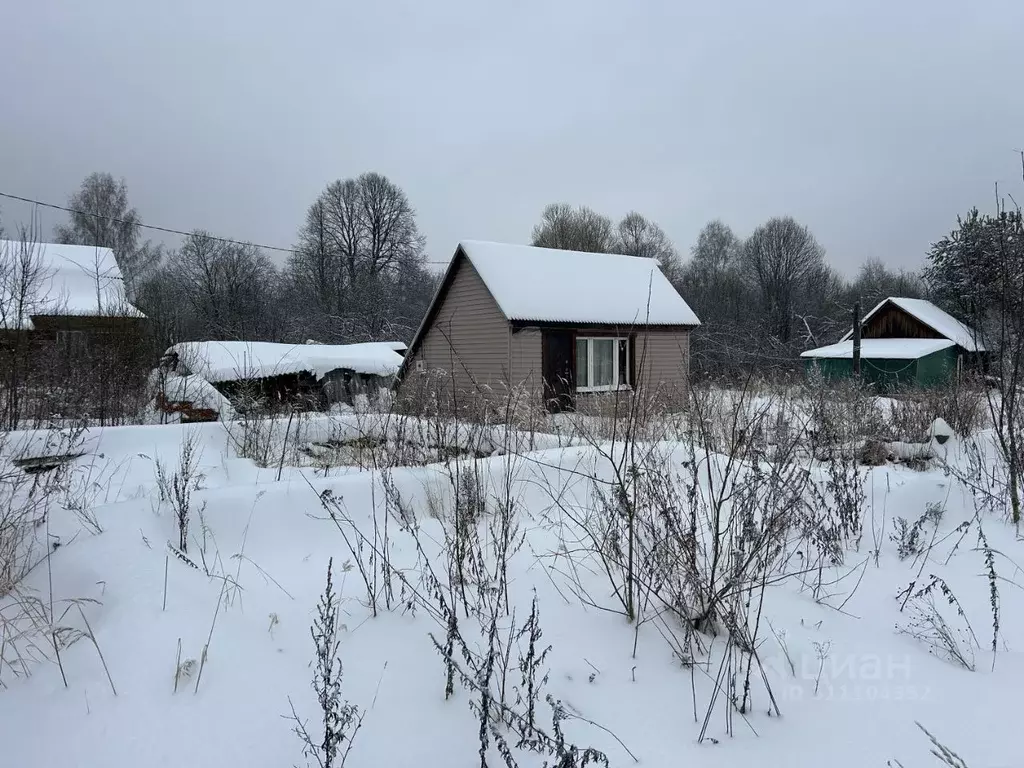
[0,0,1024,274]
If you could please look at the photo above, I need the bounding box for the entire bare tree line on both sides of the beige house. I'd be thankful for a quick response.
[41,172,932,372]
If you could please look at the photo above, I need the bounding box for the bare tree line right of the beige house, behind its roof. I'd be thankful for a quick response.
[532,204,929,374]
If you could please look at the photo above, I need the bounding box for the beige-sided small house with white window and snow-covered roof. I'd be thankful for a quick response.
[398,241,700,411]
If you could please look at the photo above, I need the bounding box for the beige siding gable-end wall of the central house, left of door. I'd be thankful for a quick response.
[402,260,511,395]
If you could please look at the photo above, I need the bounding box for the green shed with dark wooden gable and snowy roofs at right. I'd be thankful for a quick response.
[801,296,987,390]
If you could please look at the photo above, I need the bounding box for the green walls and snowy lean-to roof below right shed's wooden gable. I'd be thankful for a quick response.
[801,339,957,392]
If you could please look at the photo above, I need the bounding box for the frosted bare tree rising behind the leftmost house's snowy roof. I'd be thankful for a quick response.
[54,173,160,297]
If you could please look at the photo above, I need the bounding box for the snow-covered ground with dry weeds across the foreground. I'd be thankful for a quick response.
[0,416,1024,768]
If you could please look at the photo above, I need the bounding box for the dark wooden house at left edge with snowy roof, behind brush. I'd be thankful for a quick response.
[0,241,151,425]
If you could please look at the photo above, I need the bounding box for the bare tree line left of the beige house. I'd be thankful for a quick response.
[40,173,436,347]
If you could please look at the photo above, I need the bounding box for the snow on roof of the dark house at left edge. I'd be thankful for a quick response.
[0,240,145,329]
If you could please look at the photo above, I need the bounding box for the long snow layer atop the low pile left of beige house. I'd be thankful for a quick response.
[167,341,402,382]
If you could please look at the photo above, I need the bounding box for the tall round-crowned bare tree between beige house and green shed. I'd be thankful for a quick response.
[742,216,834,344]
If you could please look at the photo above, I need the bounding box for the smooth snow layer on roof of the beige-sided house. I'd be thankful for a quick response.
[457,241,700,326]
